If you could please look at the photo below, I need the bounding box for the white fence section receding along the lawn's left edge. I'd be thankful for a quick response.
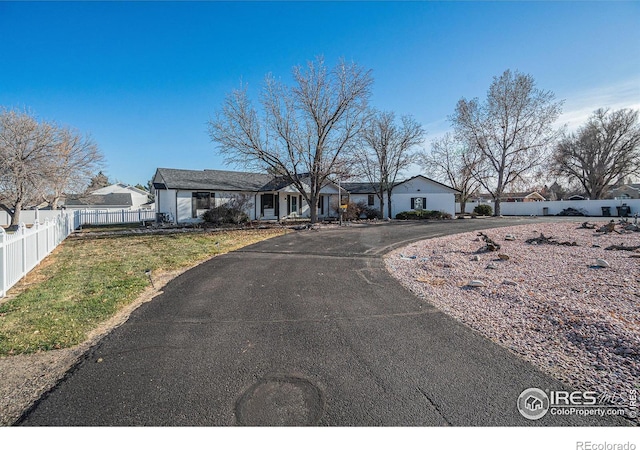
[0,213,75,297]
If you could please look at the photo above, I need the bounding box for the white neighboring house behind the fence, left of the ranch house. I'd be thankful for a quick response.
[64,183,153,210]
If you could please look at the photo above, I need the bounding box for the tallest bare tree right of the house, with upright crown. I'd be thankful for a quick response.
[451,70,562,215]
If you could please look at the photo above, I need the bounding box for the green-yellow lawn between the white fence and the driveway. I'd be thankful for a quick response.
[0,230,284,356]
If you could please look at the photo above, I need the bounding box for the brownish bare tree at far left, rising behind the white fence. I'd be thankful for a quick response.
[0,108,102,225]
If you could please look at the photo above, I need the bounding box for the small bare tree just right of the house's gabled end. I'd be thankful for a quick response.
[419,133,480,214]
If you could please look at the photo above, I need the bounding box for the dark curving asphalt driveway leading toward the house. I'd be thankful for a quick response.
[21,219,622,426]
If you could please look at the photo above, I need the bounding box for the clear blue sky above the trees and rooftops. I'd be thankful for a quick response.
[0,1,640,184]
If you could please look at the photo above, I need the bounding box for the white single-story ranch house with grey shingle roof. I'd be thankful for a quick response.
[153,168,457,223]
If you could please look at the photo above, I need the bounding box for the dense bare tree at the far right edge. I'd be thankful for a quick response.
[552,108,640,199]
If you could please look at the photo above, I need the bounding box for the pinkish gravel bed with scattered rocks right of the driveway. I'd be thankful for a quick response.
[385,222,640,420]
